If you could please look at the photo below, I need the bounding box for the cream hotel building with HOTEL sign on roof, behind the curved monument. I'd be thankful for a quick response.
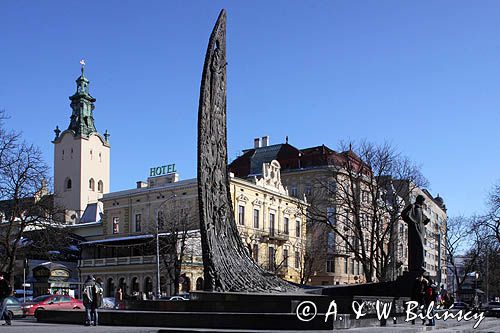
[79,161,306,296]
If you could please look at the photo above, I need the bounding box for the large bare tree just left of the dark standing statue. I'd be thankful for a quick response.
[308,141,427,282]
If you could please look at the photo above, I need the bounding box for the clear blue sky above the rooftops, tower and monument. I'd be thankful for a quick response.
[0,0,500,215]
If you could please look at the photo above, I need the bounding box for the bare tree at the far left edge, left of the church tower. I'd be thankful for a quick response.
[0,112,64,282]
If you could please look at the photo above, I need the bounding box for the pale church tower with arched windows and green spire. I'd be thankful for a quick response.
[52,60,111,224]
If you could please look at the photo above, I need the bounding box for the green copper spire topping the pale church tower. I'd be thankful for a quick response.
[68,60,97,137]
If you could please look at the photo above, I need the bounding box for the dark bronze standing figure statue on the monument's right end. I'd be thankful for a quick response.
[401,195,430,275]
